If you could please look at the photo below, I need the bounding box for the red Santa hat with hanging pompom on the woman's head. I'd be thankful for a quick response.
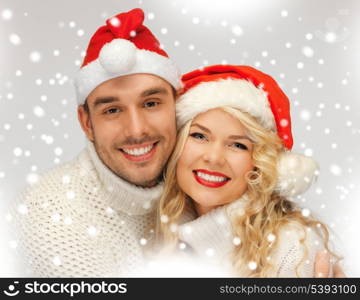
[176,65,318,197]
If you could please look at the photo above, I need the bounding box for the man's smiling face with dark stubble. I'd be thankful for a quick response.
[78,74,176,187]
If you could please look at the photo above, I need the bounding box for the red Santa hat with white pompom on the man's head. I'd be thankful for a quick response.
[75,8,181,104]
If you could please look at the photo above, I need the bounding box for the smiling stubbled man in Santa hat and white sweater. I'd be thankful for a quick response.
[14,9,344,277]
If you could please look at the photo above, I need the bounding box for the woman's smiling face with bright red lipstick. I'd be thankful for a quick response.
[176,109,254,215]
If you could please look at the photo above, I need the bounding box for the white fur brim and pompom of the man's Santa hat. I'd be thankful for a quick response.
[75,39,182,104]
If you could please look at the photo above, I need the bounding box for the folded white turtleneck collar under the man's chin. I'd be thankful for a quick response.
[86,141,163,215]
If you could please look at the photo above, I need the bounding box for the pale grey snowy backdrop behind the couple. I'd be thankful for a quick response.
[0,0,360,276]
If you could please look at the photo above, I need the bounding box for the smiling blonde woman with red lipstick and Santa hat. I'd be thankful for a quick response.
[157,65,340,277]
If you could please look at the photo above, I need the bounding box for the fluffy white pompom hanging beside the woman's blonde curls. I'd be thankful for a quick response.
[276,151,319,197]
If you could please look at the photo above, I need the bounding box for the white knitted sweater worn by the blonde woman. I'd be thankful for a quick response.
[179,201,324,277]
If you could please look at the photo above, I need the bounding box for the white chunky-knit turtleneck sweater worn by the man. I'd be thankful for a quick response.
[13,142,163,277]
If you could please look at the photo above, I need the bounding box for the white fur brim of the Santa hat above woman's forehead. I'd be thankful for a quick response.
[176,78,276,131]
